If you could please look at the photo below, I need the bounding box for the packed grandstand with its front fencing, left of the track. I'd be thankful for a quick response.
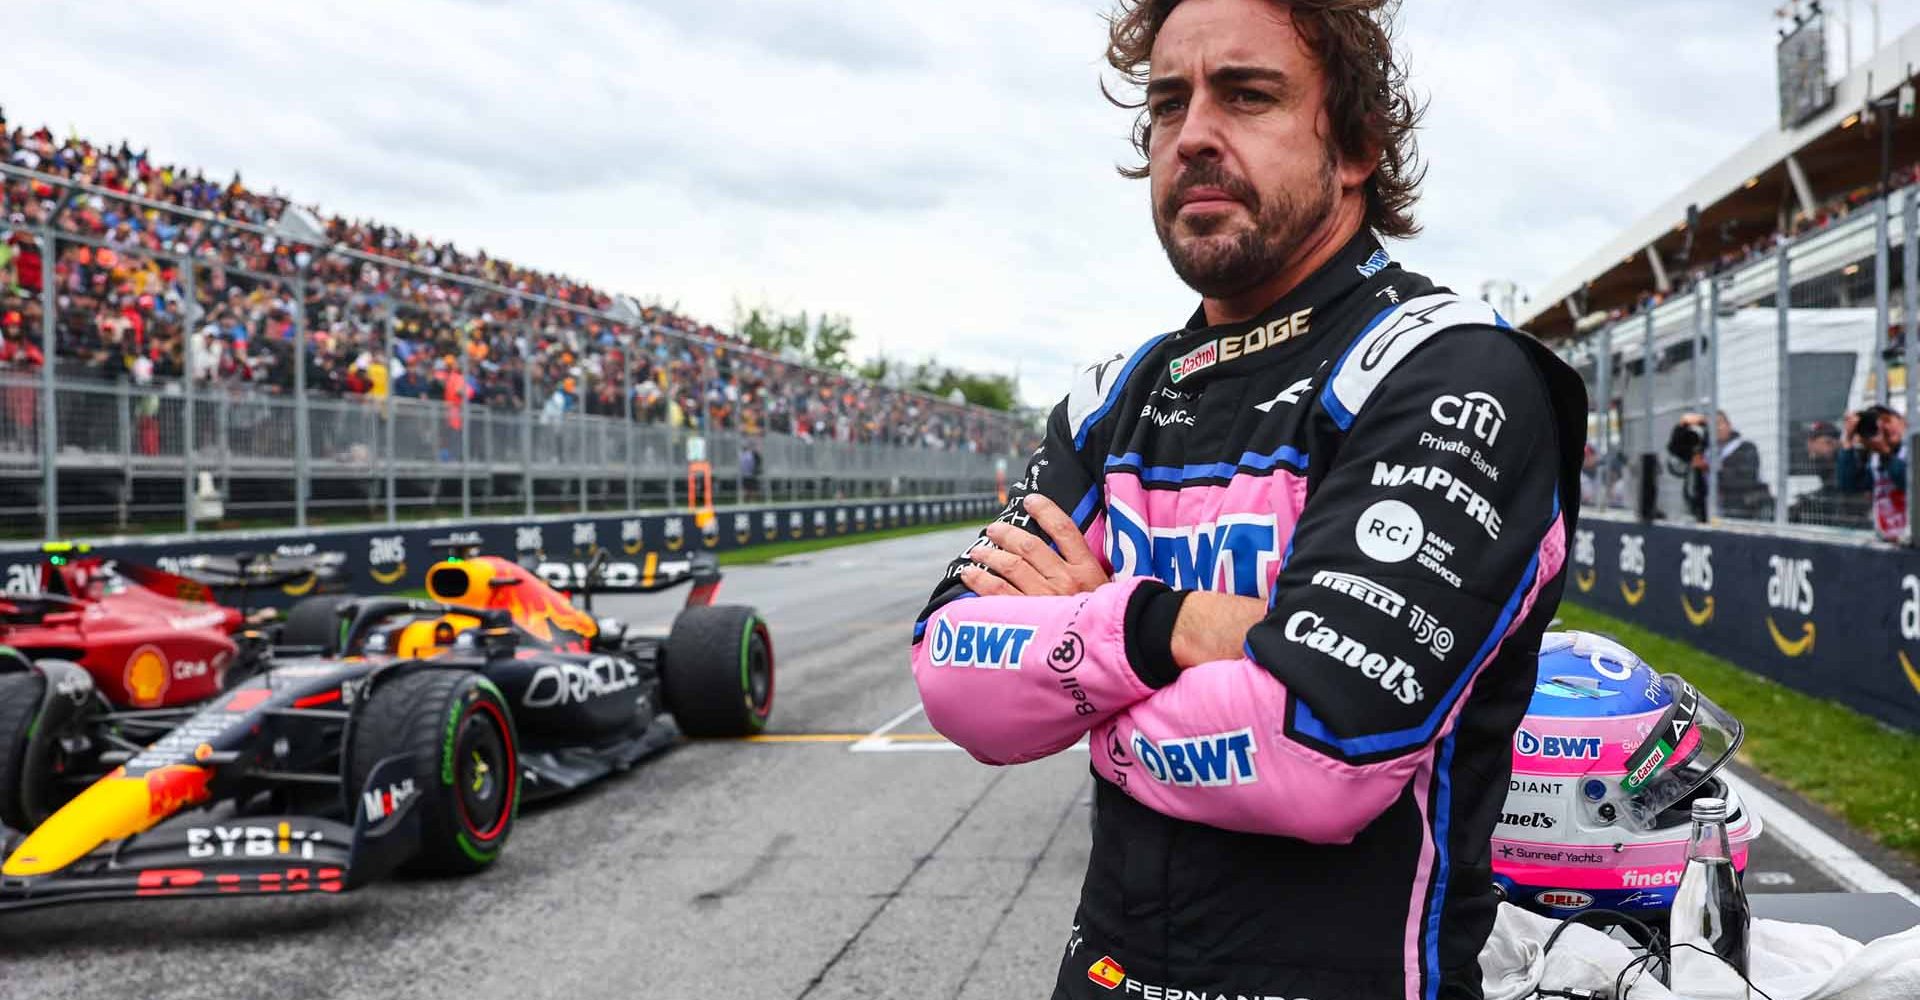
[0,117,1031,536]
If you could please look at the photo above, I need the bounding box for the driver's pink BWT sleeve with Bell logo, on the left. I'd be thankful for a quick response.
[914,576,1154,764]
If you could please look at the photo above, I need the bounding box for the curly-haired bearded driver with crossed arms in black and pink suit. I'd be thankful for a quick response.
[912,0,1586,1000]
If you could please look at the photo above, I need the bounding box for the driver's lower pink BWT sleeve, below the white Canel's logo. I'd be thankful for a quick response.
[1092,658,1432,845]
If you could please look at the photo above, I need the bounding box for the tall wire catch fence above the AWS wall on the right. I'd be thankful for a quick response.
[1559,186,1920,536]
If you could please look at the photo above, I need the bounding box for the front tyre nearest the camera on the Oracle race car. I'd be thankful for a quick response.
[346,670,520,875]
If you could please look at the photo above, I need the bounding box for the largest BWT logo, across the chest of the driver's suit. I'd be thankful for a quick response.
[1106,501,1279,597]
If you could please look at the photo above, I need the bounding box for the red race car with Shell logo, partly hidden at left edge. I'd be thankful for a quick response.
[0,541,334,825]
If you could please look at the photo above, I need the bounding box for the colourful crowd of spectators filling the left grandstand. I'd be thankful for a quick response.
[0,111,1031,453]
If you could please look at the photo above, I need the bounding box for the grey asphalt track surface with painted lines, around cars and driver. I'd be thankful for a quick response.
[0,530,1920,1000]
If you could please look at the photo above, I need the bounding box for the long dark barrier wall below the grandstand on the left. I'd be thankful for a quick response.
[0,495,1000,608]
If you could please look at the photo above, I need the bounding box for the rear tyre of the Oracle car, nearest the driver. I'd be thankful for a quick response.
[662,605,774,737]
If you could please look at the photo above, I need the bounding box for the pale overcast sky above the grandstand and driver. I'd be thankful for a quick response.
[0,0,1920,403]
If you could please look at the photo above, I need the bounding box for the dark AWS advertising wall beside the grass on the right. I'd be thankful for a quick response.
[1567,516,1920,731]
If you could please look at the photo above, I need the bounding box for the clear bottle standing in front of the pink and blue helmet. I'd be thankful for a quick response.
[1670,798,1753,1000]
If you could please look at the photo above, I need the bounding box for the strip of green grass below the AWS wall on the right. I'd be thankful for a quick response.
[1559,603,1920,862]
